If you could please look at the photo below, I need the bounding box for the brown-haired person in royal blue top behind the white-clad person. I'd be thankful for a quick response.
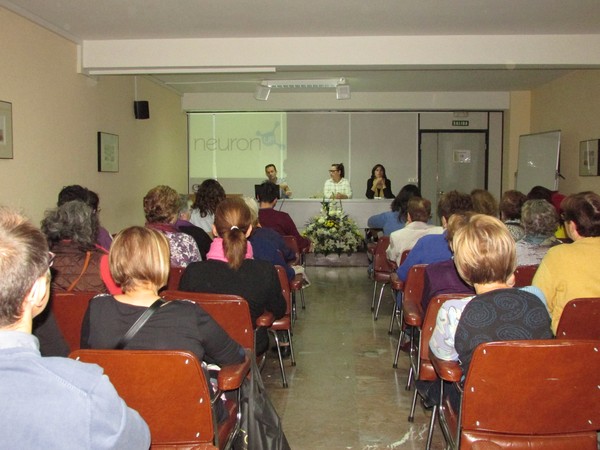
[396,191,473,281]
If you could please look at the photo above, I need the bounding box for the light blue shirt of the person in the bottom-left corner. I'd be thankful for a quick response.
[0,331,150,450]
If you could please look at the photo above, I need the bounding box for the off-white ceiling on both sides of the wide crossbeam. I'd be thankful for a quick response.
[0,0,600,94]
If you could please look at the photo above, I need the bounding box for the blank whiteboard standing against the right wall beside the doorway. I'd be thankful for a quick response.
[516,130,560,194]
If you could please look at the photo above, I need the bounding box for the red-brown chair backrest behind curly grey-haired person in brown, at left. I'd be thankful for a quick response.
[50,291,99,351]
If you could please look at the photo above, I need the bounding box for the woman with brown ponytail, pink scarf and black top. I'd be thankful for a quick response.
[179,198,286,354]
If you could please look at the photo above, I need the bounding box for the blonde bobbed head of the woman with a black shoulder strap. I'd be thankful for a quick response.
[108,226,170,292]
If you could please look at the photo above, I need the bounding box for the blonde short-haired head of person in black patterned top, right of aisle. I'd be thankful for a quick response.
[452,214,517,285]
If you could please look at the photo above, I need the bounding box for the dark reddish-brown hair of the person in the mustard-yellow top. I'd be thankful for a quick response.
[560,191,600,237]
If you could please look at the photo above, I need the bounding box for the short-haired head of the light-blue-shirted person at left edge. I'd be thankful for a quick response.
[0,207,49,327]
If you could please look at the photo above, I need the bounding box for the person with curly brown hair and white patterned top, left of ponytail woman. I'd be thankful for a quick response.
[144,186,202,267]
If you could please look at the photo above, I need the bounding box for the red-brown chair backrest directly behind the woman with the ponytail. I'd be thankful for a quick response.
[160,290,254,350]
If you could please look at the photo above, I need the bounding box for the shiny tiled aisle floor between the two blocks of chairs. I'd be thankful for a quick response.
[263,267,444,450]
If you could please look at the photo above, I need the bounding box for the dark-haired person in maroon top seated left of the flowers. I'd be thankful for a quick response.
[258,181,311,252]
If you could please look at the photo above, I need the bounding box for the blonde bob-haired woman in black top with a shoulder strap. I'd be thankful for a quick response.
[81,227,245,420]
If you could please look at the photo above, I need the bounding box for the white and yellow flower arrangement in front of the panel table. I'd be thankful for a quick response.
[302,200,364,255]
